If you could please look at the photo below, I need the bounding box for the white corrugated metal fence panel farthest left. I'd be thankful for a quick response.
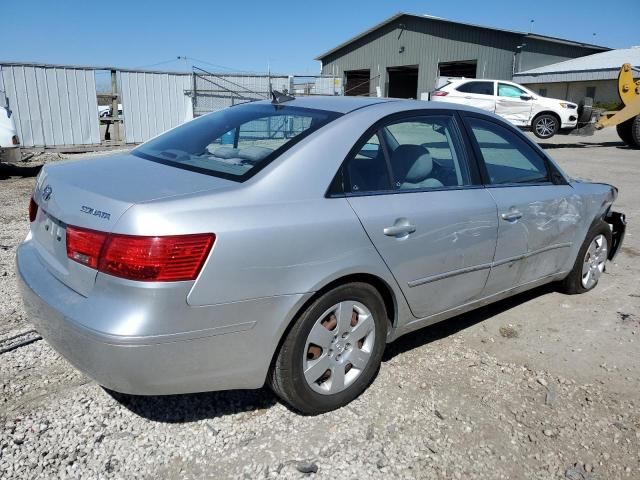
[0,65,100,147]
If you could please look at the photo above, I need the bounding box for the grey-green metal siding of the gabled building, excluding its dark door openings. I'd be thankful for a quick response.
[322,16,596,96]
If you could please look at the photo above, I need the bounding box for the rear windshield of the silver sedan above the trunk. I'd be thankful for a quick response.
[132,104,340,181]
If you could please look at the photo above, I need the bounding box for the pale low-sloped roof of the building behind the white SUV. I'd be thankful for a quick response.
[513,46,640,83]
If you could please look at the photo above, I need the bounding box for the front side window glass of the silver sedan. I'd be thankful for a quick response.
[468,117,550,185]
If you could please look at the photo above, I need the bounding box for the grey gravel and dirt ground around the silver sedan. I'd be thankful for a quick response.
[0,131,640,480]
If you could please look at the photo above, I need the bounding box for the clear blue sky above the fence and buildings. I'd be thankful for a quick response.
[0,0,640,75]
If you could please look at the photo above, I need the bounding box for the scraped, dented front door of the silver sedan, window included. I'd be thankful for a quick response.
[465,114,582,295]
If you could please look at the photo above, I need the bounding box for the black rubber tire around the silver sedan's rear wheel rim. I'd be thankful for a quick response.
[268,282,388,415]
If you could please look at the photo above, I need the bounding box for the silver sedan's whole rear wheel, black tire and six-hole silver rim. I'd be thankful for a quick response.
[269,283,387,414]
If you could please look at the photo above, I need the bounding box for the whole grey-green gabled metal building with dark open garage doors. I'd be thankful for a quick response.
[316,13,609,98]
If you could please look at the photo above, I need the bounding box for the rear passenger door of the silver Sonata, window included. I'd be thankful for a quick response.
[343,111,497,317]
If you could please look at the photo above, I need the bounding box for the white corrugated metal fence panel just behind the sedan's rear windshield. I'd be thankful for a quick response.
[120,72,193,143]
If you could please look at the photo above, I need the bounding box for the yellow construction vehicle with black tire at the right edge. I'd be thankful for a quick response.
[595,63,640,148]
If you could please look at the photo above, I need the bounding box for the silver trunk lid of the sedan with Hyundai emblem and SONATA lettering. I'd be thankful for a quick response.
[31,154,237,296]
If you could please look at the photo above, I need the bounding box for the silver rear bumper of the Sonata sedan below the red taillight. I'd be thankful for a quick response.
[16,242,308,395]
